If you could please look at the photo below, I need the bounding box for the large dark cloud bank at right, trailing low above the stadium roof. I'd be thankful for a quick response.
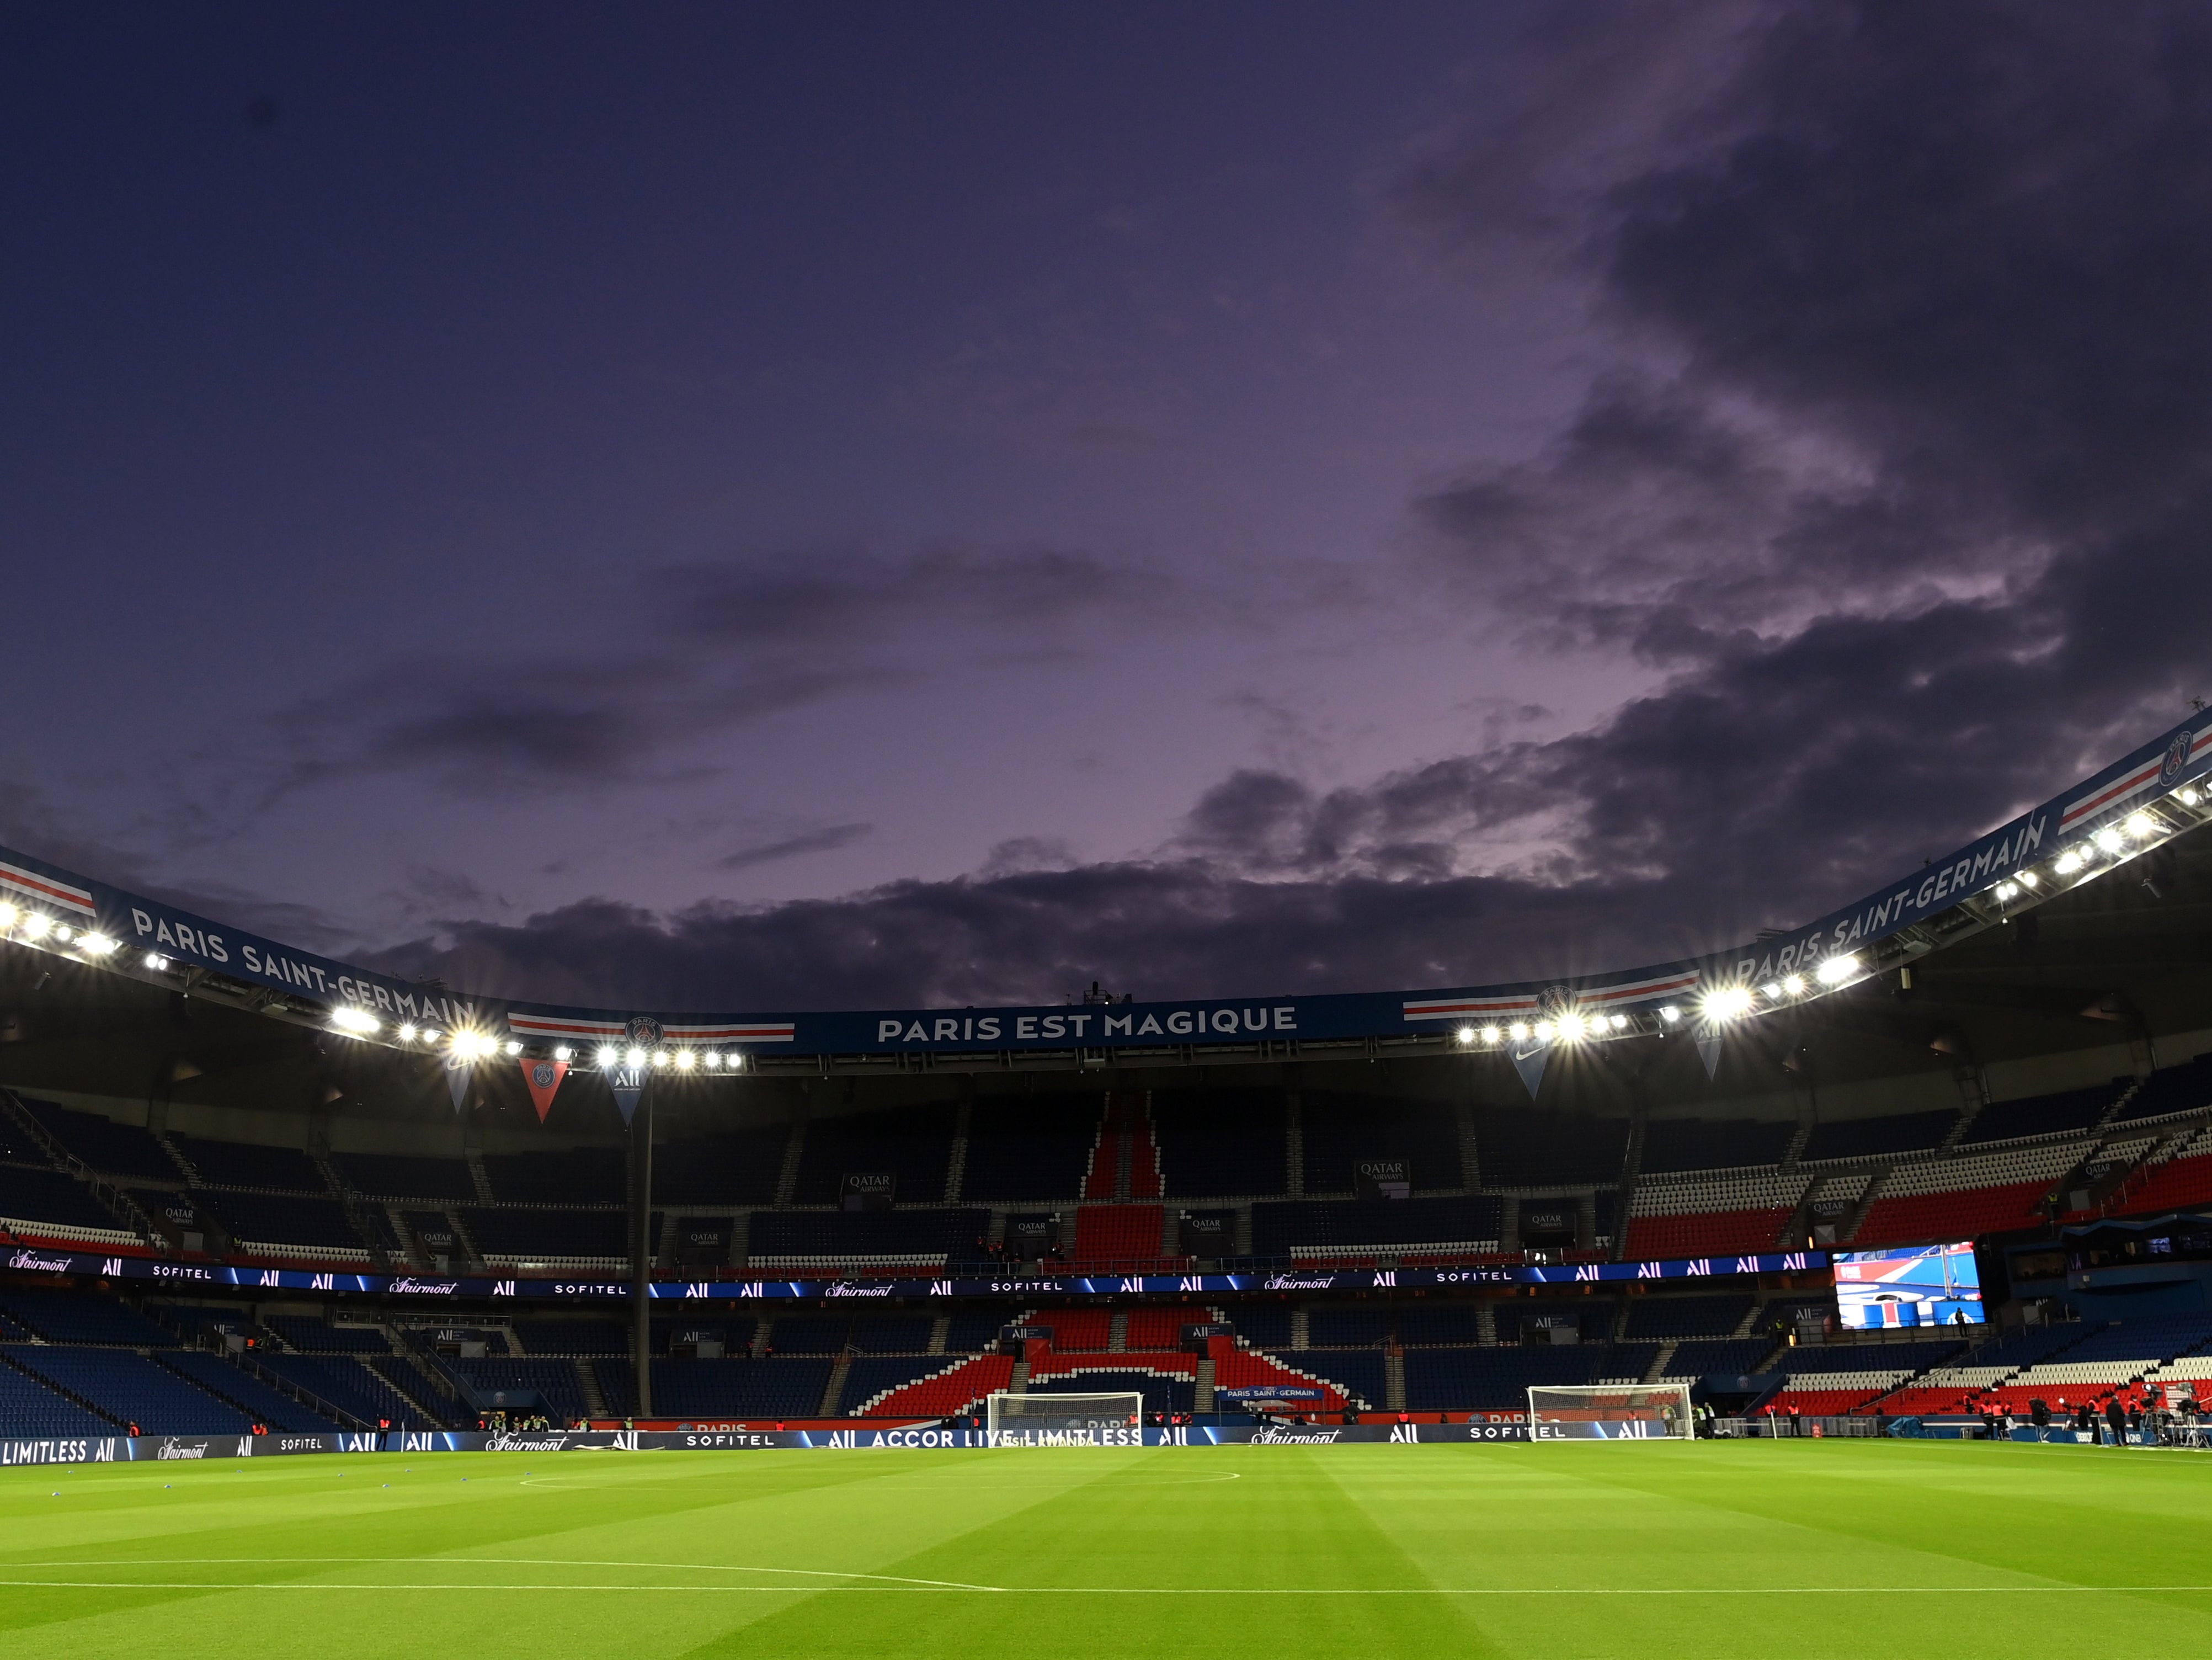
[312,0,2212,1007]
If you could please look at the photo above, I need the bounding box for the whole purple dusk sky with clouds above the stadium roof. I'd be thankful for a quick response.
[0,0,2212,1012]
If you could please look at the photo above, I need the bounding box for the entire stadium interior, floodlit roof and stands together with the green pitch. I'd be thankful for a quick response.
[0,721,2212,1653]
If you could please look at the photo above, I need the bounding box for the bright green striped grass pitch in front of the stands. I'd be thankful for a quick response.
[0,1441,2212,1660]
